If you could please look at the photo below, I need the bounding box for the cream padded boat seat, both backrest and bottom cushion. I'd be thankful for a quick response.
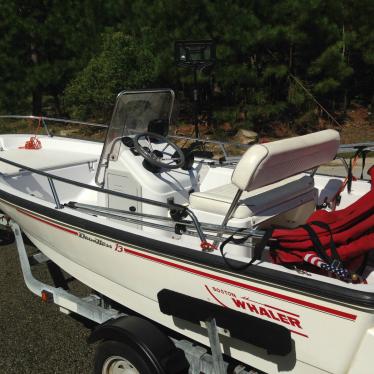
[190,130,340,227]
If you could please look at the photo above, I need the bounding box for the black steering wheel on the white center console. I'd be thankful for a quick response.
[134,132,185,170]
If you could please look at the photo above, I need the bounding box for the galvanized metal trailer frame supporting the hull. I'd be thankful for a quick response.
[0,215,257,374]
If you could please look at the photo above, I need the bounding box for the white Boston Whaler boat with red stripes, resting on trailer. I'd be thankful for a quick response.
[0,90,374,374]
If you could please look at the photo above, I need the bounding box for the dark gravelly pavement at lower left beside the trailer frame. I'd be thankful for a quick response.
[0,245,95,374]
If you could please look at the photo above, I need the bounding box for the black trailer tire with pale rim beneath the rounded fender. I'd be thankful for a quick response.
[94,340,157,374]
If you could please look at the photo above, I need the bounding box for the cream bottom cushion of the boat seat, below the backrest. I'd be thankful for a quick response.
[190,174,314,218]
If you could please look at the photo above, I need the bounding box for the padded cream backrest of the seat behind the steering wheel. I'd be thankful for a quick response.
[231,130,340,191]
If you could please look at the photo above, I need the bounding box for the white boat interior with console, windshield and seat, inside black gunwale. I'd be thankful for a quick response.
[0,91,374,292]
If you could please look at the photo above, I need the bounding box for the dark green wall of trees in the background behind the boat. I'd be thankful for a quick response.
[0,0,374,129]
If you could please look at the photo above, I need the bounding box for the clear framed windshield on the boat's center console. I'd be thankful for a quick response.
[100,90,174,163]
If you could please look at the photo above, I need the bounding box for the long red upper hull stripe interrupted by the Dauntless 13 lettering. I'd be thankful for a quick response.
[18,209,357,321]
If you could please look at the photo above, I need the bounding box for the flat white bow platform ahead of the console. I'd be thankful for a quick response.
[0,148,98,176]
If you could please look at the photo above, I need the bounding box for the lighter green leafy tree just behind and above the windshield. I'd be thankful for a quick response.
[65,31,158,119]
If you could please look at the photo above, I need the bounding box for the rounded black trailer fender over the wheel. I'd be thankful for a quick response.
[87,316,189,374]
